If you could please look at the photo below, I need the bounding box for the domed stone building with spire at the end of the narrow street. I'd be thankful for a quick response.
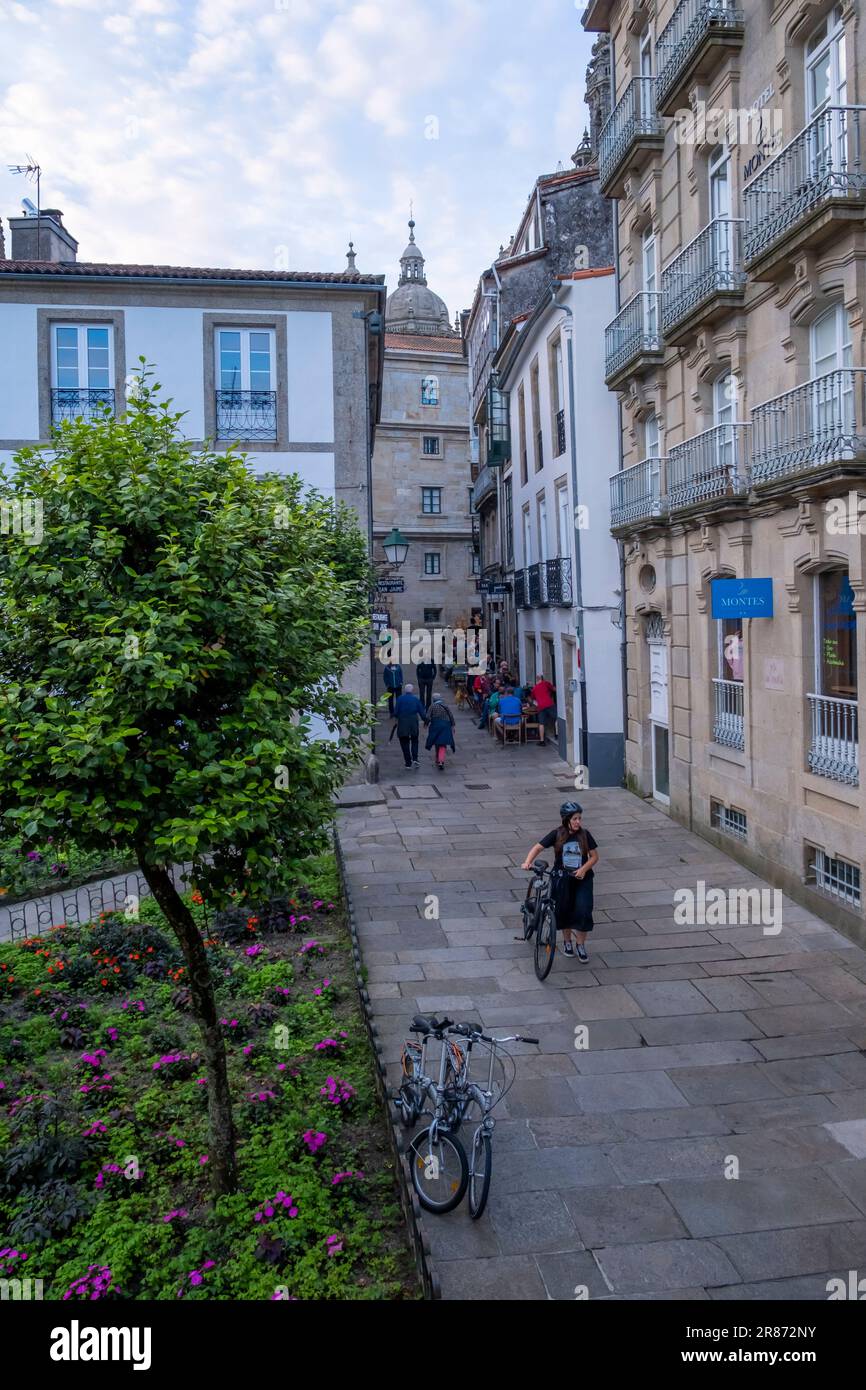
[373,221,478,631]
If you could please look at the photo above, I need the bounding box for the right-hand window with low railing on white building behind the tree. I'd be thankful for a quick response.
[215,328,277,441]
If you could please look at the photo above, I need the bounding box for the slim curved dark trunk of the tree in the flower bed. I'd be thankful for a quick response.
[138,849,238,1197]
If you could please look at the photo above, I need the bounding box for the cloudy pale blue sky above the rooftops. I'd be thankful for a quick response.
[0,0,592,317]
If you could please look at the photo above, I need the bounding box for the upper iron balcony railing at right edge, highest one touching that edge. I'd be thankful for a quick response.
[742,106,866,264]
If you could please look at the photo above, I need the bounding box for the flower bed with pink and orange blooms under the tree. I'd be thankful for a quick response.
[0,858,420,1301]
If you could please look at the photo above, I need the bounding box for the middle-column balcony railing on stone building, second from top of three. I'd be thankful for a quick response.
[662,217,745,335]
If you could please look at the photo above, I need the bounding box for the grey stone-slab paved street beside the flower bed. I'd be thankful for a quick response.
[339,714,866,1300]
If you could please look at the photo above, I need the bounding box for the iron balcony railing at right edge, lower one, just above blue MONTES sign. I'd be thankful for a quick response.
[752,367,866,485]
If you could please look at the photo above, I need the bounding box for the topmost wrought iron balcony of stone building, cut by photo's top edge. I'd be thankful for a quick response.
[656,0,745,115]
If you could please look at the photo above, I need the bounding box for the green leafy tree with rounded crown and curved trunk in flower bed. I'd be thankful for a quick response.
[0,363,370,1193]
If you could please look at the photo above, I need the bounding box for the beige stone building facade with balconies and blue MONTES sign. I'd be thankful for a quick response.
[584,0,866,940]
